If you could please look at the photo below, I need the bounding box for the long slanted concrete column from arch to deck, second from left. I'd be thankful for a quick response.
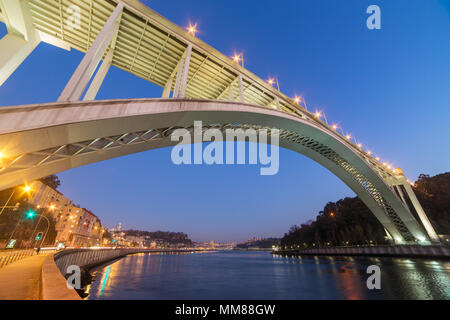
[58,2,123,102]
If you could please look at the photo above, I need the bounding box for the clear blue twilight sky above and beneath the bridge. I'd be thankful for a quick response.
[0,0,450,241]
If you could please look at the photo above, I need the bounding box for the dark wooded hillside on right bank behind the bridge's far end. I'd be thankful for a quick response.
[281,173,450,247]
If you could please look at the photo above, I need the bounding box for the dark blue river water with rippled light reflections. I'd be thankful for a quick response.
[87,251,450,300]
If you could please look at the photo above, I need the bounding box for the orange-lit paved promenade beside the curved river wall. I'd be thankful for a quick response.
[0,253,48,300]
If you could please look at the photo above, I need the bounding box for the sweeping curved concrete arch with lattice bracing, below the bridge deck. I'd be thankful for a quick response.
[0,99,438,244]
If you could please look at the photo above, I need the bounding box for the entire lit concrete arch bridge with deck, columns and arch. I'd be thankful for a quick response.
[0,0,439,245]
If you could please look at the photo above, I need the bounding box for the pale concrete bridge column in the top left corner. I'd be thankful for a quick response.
[0,0,41,86]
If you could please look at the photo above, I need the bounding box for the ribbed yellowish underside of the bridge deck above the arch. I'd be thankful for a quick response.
[0,0,394,179]
